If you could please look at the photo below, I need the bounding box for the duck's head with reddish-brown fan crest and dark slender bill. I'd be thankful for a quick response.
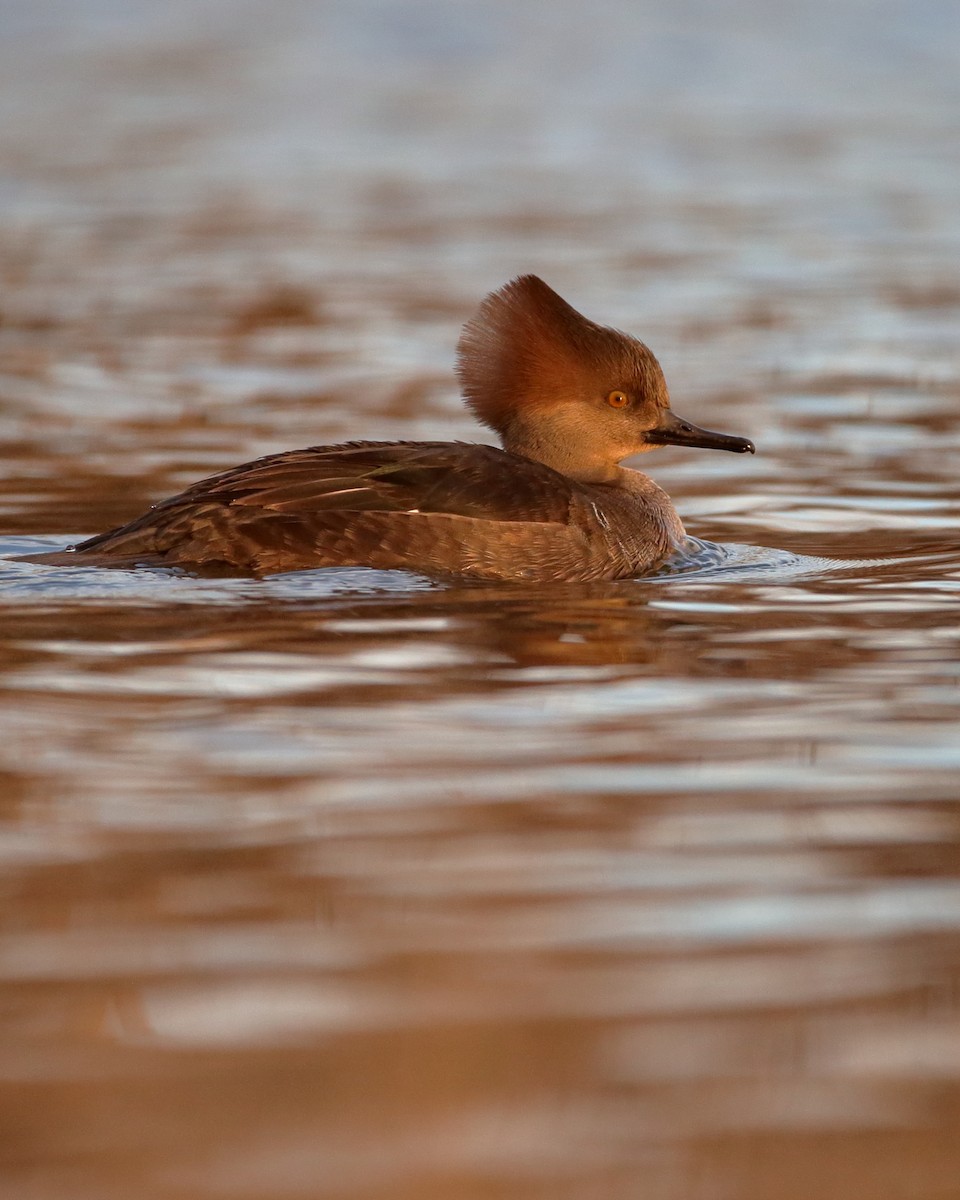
[457,275,754,482]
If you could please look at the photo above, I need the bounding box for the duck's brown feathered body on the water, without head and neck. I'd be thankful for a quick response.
[46,442,684,581]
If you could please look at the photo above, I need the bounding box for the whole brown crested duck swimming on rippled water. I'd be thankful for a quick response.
[24,275,755,583]
